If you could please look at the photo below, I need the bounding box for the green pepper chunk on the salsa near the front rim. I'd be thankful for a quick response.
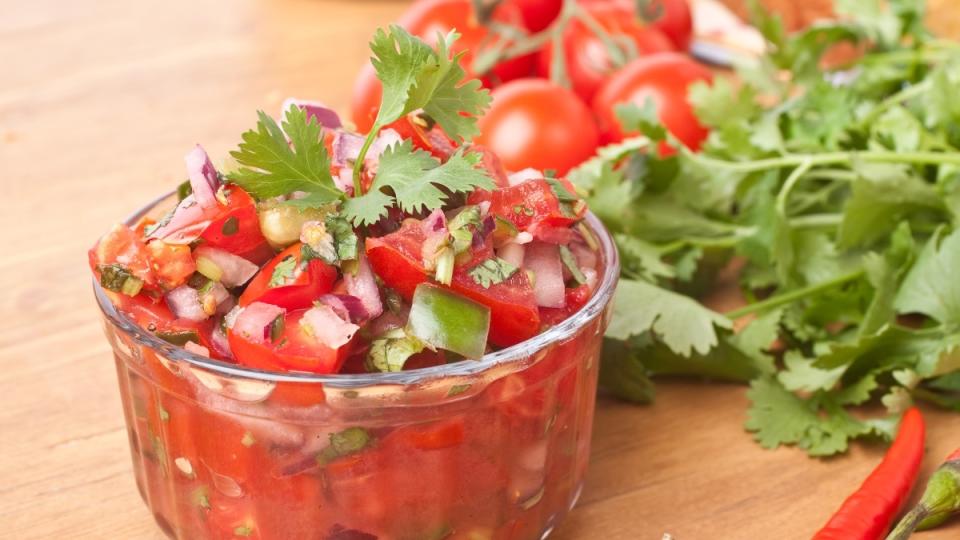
[407,283,490,359]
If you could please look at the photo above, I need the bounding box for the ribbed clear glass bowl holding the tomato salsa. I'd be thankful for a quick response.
[94,195,619,540]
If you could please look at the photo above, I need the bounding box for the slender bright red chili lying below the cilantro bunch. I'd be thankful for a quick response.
[813,407,926,540]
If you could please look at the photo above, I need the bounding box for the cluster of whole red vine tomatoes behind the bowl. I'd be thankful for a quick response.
[352,0,711,175]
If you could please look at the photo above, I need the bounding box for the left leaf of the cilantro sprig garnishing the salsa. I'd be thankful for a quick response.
[227,105,343,205]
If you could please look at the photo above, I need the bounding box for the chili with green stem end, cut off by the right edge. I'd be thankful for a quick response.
[887,448,960,540]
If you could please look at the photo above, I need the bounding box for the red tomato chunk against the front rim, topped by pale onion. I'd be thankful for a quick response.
[227,309,353,374]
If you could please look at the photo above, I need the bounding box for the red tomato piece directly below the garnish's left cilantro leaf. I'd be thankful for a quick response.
[200,185,267,262]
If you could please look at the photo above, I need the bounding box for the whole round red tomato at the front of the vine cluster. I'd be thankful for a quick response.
[477,79,598,175]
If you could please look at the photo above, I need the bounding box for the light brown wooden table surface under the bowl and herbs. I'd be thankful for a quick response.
[0,0,960,540]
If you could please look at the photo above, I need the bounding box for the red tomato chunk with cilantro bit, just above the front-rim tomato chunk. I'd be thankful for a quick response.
[240,242,337,309]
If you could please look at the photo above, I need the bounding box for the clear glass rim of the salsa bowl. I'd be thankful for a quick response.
[92,191,620,389]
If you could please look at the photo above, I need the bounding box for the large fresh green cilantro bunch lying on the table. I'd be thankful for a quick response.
[571,0,960,456]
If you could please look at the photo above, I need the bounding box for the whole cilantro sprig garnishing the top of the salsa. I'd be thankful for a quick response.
[228,26,493,227]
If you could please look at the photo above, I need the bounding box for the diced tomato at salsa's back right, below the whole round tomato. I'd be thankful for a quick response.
[467,180,586,231]
